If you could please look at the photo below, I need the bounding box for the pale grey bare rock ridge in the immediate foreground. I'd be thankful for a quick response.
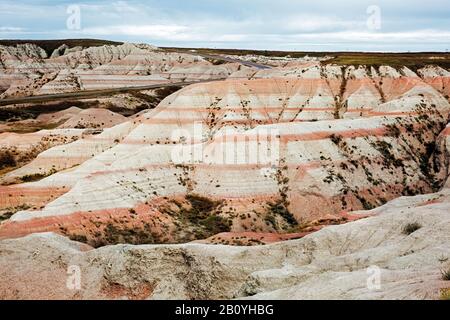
[0,189,450,299]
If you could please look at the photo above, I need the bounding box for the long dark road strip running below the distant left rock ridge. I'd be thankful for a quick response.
[0,78,226,106]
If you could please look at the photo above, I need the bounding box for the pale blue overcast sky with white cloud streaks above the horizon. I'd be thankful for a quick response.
[0,0,450,51]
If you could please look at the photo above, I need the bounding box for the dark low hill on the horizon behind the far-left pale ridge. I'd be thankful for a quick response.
[0,39,123,55]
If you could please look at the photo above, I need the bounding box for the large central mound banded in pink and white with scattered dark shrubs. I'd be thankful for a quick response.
[0,67,450,246]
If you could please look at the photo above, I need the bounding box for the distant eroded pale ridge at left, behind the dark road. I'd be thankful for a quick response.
[0,43,246,97]
